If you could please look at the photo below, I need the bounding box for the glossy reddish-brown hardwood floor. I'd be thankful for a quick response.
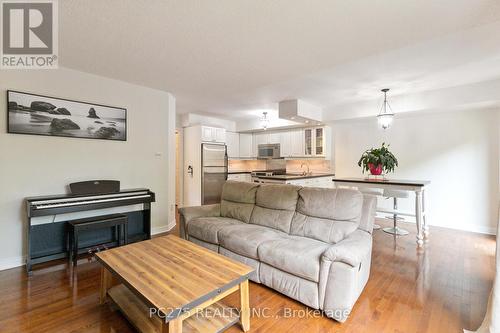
[0,220,495,333]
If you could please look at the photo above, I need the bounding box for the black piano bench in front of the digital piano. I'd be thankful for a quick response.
[66,214,128,266]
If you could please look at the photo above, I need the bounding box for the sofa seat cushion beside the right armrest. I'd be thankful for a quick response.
[258,236,330,282]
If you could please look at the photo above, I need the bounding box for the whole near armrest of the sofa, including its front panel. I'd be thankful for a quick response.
[319,229,372,322]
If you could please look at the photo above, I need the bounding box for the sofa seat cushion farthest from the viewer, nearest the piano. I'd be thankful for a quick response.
[187,217,243,244]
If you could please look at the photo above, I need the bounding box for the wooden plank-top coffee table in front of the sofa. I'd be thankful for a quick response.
[96,235,253,333]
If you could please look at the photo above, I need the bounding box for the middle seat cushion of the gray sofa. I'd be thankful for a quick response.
[218,224,288,259]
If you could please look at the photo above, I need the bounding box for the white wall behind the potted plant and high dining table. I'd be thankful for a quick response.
[332,110,500,233]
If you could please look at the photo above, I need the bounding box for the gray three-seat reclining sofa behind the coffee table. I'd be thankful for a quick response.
[180,181,376,322]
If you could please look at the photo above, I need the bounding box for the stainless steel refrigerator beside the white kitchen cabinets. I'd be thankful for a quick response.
[201,143,227,205]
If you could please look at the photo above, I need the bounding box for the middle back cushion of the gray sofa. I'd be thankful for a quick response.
[250,184,301,233]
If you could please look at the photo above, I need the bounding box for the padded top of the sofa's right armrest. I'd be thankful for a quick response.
[321,229,372,267]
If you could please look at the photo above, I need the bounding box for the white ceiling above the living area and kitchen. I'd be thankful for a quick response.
[59,0,500,120]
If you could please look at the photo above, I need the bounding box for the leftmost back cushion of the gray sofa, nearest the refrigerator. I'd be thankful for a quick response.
[220,180,259,223]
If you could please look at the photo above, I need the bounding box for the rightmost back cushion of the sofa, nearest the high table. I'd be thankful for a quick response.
[290,187,363,244]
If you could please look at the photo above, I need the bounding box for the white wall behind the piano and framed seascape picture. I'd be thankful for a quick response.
[0,69,175,270]
